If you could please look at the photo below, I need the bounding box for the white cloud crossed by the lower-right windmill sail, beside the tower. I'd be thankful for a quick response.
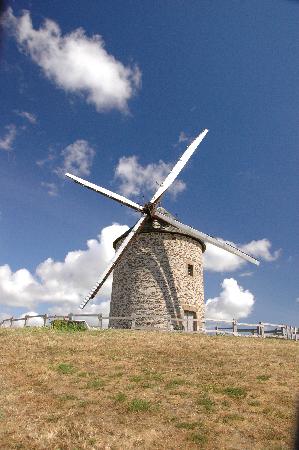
[204,238,281,272]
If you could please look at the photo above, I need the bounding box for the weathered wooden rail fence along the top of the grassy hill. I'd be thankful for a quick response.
[0,313,299,341]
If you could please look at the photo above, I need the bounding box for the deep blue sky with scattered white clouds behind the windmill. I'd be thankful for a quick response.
[0,0,299,324]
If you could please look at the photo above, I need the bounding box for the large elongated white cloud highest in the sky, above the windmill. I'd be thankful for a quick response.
[4,8,141,111]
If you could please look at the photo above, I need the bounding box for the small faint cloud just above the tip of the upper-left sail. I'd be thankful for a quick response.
[55,139,95,178]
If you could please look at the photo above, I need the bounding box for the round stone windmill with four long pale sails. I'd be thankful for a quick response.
[66,129,259,328]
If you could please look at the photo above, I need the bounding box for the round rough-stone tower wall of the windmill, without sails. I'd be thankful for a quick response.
[110,231,204,328]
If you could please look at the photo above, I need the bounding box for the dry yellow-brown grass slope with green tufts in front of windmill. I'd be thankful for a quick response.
[0,329,299,450]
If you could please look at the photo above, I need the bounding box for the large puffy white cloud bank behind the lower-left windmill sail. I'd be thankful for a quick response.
[0,224,128,312]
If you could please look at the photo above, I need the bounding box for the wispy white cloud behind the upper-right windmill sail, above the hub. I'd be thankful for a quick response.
[115,155,186,196]
